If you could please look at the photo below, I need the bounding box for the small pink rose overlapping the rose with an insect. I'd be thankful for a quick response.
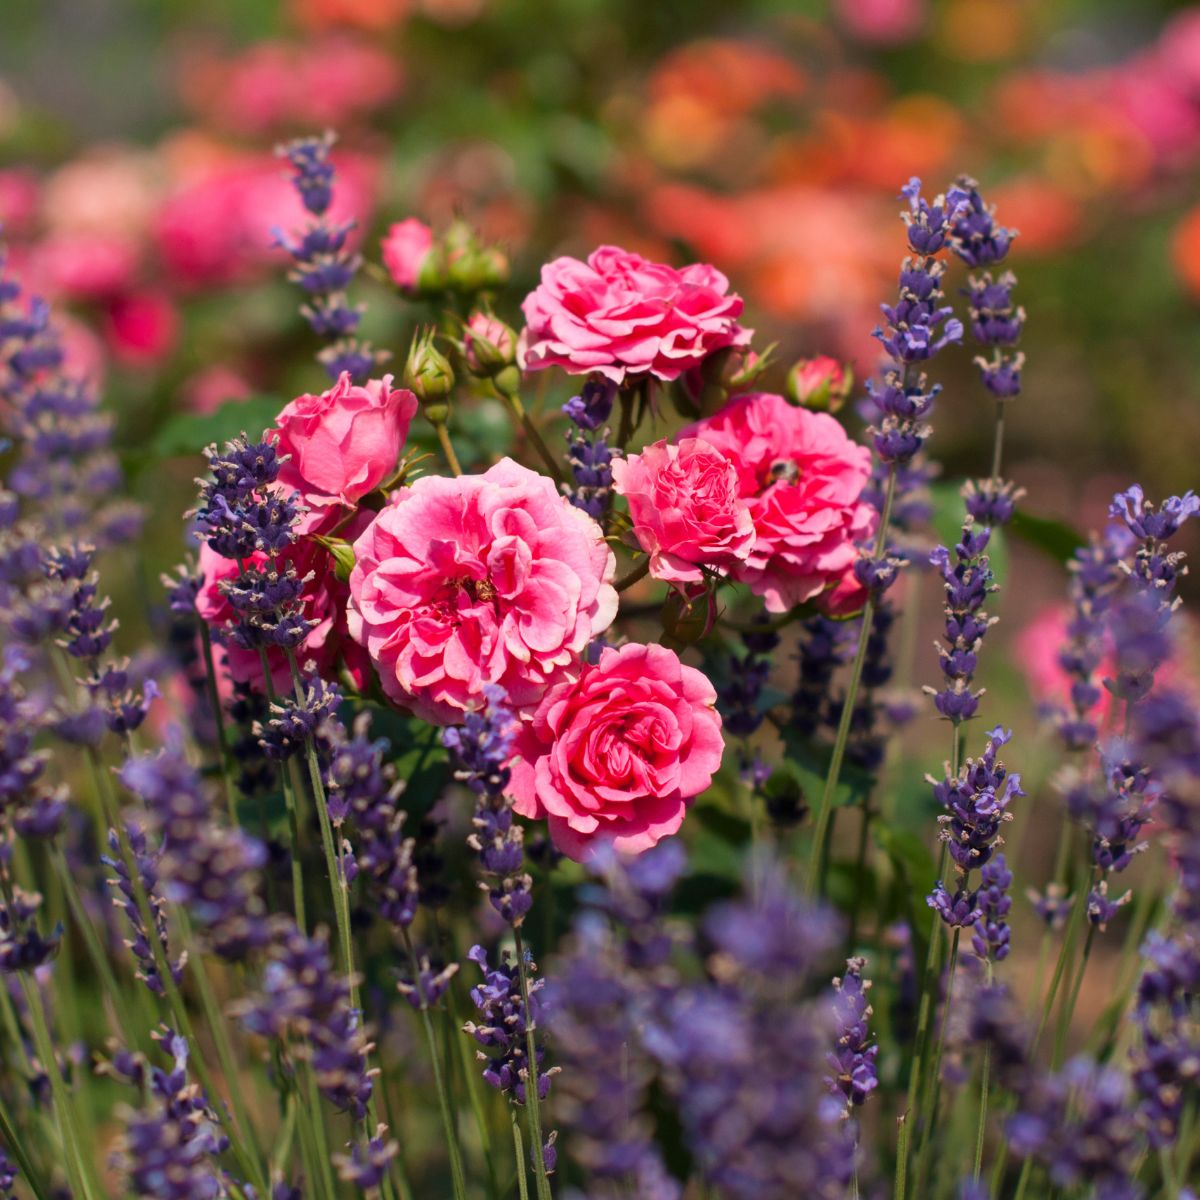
[612,438,755,583]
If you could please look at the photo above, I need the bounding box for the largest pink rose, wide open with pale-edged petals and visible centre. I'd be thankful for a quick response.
[349,458,617,724]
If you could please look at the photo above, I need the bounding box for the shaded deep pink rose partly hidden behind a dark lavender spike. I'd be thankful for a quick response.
[196,511,371,695]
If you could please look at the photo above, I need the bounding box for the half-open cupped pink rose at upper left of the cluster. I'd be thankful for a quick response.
[268,371,416,506]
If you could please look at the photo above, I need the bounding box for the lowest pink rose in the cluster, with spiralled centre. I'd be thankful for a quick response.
[511,644,725,860]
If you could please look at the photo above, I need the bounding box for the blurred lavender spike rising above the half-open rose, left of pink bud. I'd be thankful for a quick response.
[275,133,382,384]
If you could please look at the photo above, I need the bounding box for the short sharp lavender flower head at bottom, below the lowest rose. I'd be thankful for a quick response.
[463,946,558,1104]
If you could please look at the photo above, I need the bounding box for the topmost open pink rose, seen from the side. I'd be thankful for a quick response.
[518,246,750,383]
